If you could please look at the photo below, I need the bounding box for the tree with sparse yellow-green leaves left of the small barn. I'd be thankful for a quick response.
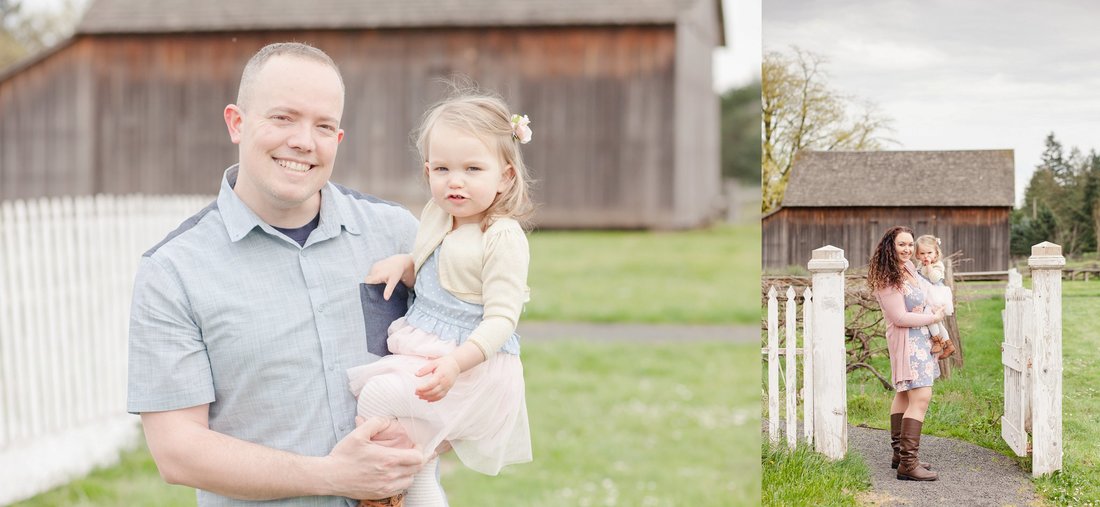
[760,47,894,213]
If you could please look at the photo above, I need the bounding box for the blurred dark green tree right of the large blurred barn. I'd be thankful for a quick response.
[722,81,760,186]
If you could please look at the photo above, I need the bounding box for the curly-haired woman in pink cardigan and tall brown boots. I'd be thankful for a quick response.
[867,227,944,481]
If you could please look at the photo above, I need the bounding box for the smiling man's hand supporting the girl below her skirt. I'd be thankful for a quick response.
[327,417,424,499]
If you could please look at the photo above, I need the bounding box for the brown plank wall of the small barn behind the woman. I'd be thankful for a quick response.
[761,207,1011,272]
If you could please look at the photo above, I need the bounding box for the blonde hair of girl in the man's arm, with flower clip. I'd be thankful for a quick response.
[414,90,535,230]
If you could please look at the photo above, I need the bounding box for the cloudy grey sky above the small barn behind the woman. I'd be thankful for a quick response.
[763,0,1100,205]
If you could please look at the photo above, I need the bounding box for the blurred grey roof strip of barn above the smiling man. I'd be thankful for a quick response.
[77,0,722,36]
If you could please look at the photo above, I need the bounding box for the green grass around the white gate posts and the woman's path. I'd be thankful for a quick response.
[763,282,1100,506]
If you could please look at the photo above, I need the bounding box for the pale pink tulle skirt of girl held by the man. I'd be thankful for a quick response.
[348,318,531,475]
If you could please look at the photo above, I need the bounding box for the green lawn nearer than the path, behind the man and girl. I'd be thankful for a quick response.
[17,341,760,507]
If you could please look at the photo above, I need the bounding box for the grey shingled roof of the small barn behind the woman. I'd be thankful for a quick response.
[782,150,1015,208]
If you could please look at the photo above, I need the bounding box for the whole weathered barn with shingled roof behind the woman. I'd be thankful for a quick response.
[762,150,1015,272]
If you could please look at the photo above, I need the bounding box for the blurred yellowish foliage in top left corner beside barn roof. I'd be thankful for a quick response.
[0,0,80,70]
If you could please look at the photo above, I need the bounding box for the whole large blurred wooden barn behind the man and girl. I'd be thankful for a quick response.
[0,0,724,228]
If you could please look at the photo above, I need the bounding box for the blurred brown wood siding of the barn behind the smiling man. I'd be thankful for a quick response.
[0,25,704,228]
